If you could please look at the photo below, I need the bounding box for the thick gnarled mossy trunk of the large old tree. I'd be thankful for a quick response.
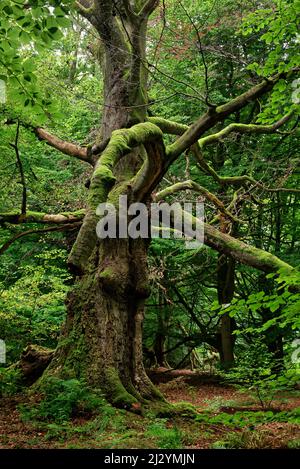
[41,0,162,409]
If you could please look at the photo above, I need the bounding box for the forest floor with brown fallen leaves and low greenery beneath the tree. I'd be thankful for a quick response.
[0,370,300,449]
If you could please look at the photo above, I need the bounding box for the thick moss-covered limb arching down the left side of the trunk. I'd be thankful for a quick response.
[68,122,163,274]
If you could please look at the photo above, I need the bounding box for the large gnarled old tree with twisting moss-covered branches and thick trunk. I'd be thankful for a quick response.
[0,0,296,408]
